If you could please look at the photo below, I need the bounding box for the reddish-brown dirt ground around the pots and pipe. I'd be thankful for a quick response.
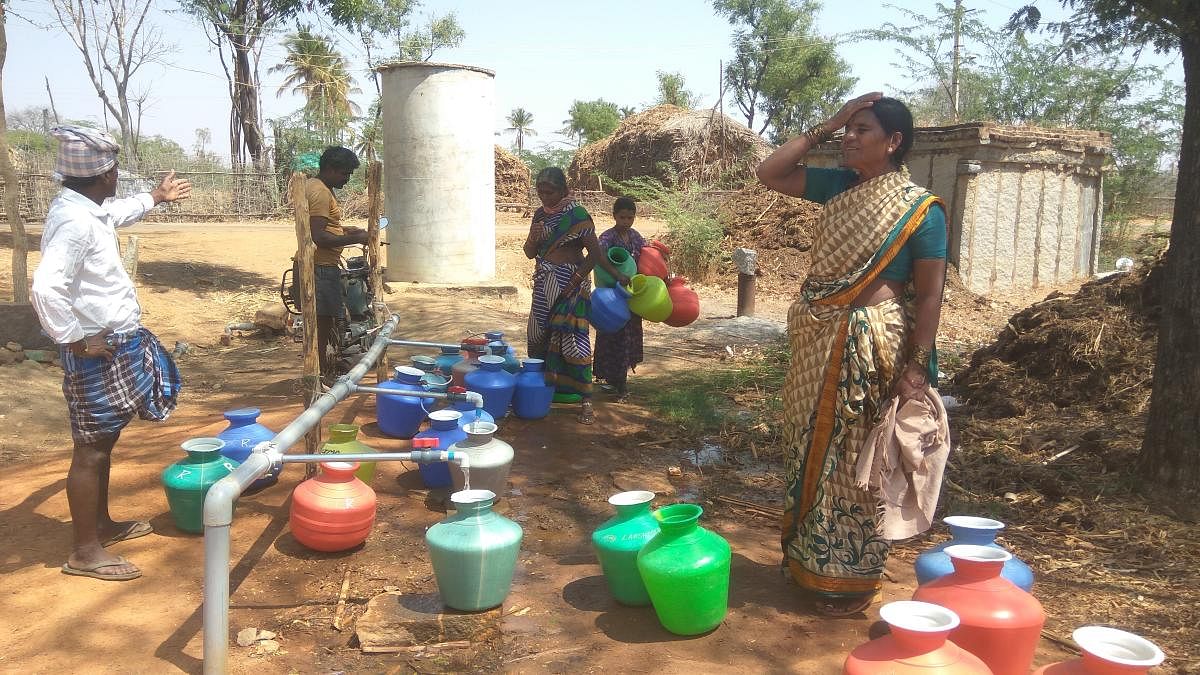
[0,208,1128,674]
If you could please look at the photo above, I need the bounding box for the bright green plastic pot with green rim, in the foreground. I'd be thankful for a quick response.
[637,504,732,635]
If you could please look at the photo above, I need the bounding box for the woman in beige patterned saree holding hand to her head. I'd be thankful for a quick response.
[757,92,947,616]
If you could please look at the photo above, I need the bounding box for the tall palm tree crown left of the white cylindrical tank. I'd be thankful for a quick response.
[269,25,360,142]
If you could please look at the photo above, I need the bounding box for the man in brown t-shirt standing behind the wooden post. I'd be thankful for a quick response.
[305,145,367,383]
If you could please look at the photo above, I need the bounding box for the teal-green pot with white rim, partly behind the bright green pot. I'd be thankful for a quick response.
[592,490,659,607]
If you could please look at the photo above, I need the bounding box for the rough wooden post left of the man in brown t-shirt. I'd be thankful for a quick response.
[288,172,322,468]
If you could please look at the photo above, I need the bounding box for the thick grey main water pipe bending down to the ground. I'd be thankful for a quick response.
[203,315,400,675]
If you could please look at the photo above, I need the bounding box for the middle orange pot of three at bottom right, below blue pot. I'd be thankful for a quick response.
[912,545,1046,675]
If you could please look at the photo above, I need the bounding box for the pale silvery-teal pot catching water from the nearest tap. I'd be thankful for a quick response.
[425,490,524,611]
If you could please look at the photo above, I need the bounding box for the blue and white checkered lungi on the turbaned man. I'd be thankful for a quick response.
[60,328,181,443]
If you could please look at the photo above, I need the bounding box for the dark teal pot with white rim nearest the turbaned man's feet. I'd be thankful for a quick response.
[162,438,238,534]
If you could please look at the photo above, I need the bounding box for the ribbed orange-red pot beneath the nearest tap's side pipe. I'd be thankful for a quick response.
[289,461,376,551]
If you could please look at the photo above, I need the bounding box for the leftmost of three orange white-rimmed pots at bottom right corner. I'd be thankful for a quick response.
[842,601,991,675]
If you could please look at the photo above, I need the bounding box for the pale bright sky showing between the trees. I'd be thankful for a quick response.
[4,0,1183,155]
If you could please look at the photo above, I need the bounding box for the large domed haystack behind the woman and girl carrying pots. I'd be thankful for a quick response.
[568,106,770,190]
